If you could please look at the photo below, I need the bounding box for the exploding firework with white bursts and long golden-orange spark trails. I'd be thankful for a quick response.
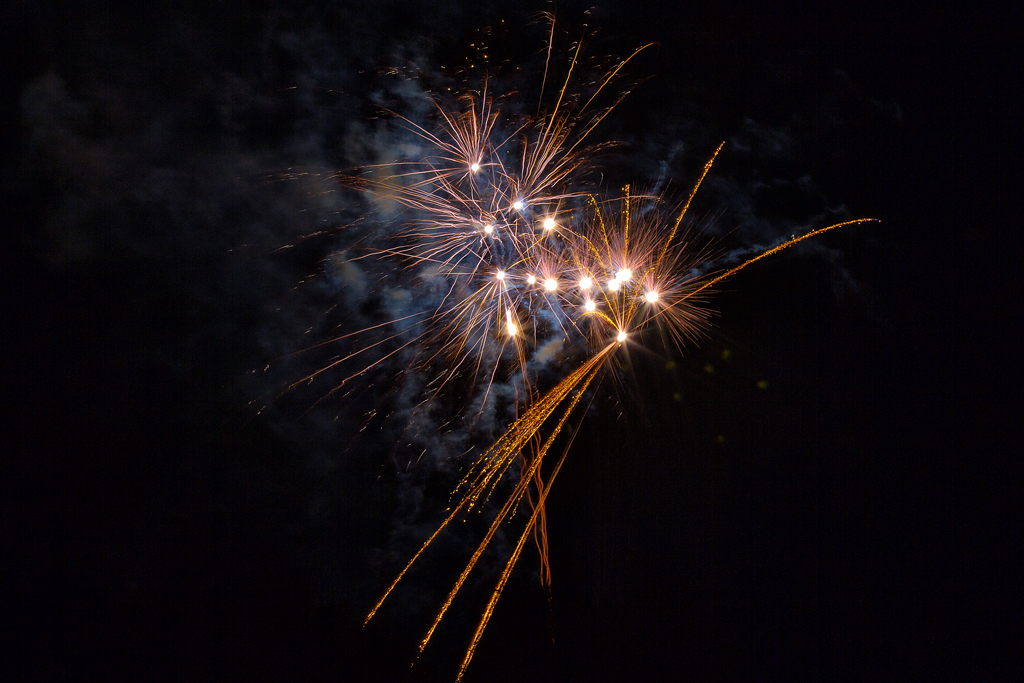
[280,17,863,679]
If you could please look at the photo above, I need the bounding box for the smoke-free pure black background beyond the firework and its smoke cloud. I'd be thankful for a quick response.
[0,2,1021,681]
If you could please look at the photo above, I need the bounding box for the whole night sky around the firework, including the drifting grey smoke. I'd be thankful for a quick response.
[0,0,1022,681]
